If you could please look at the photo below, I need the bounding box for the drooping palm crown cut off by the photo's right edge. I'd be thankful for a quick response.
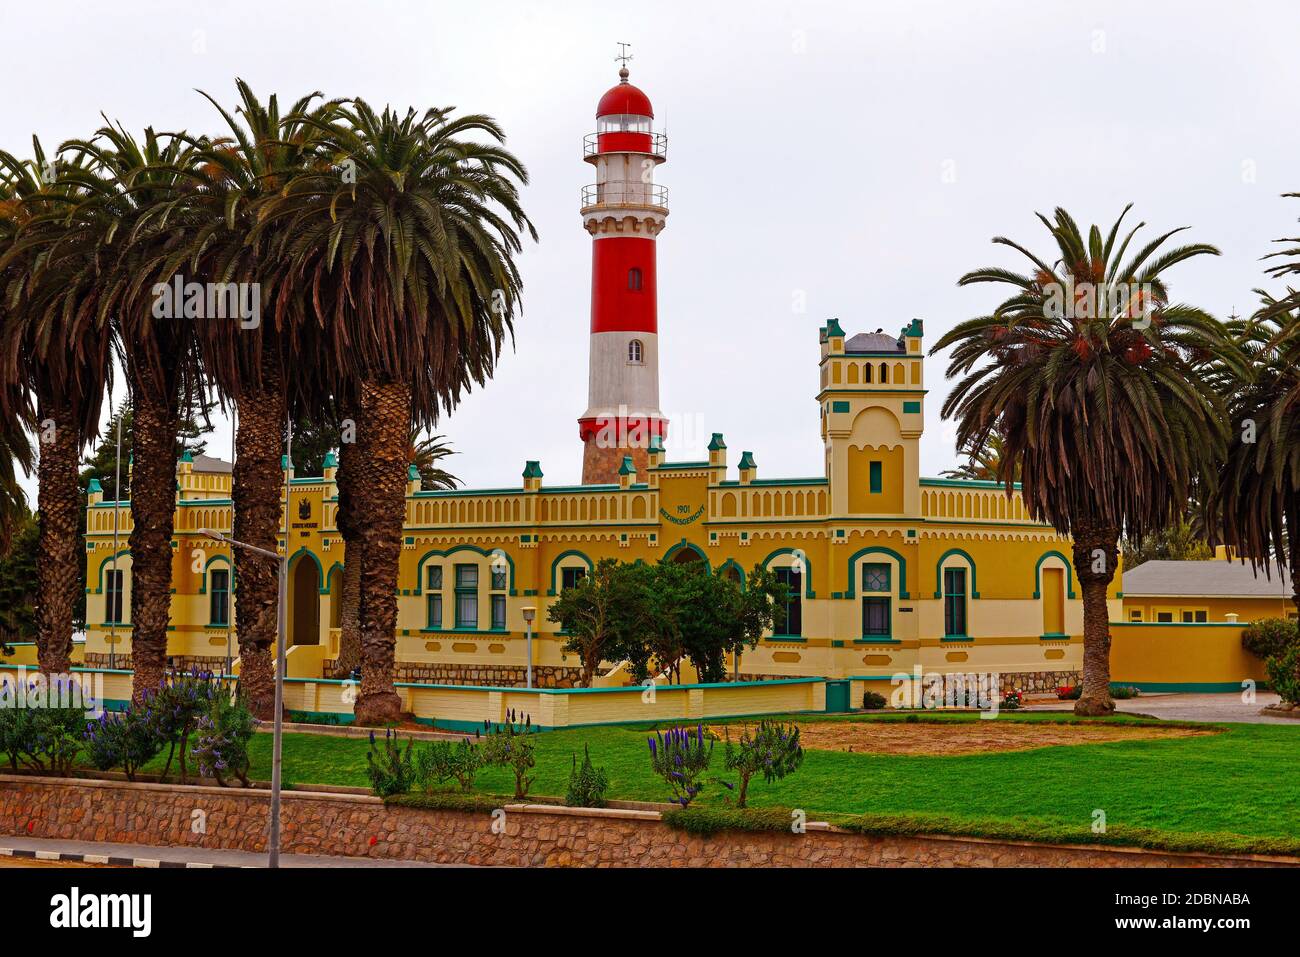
[1206,290,1300,607]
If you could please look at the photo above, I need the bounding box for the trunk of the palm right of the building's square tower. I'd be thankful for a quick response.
[1074,521,1119,716]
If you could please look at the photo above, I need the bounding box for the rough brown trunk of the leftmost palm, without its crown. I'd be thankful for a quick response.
[36,400,85,675]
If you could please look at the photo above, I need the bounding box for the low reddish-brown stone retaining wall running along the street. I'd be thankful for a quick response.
[0,775,1297,867]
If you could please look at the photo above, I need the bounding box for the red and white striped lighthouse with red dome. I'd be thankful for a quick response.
[579,57,668,485]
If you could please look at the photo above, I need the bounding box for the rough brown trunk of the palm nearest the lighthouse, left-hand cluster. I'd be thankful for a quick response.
[355,381,411,724]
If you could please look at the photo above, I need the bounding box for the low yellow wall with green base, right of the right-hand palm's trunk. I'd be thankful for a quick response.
[1110,622,1265,692]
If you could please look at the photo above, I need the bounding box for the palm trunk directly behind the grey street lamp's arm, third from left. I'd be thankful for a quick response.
[231,355,289,720]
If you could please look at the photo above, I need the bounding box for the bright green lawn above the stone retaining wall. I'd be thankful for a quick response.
[245,715,1300,853]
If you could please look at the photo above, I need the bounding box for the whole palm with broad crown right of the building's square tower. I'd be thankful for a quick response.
[932,207,1231,715]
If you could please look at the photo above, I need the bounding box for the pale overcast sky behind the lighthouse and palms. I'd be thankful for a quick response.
[0,0,1300,488]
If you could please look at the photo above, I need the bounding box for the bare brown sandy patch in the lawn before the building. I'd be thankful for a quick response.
[712,719,1216,755]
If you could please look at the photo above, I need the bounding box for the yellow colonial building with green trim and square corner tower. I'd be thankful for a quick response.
[86,320,1119,689]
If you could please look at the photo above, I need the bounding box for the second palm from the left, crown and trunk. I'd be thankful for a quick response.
[60,124,203,702]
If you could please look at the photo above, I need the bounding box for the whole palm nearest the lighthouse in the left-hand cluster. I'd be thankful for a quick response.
[267,100,536,724]
